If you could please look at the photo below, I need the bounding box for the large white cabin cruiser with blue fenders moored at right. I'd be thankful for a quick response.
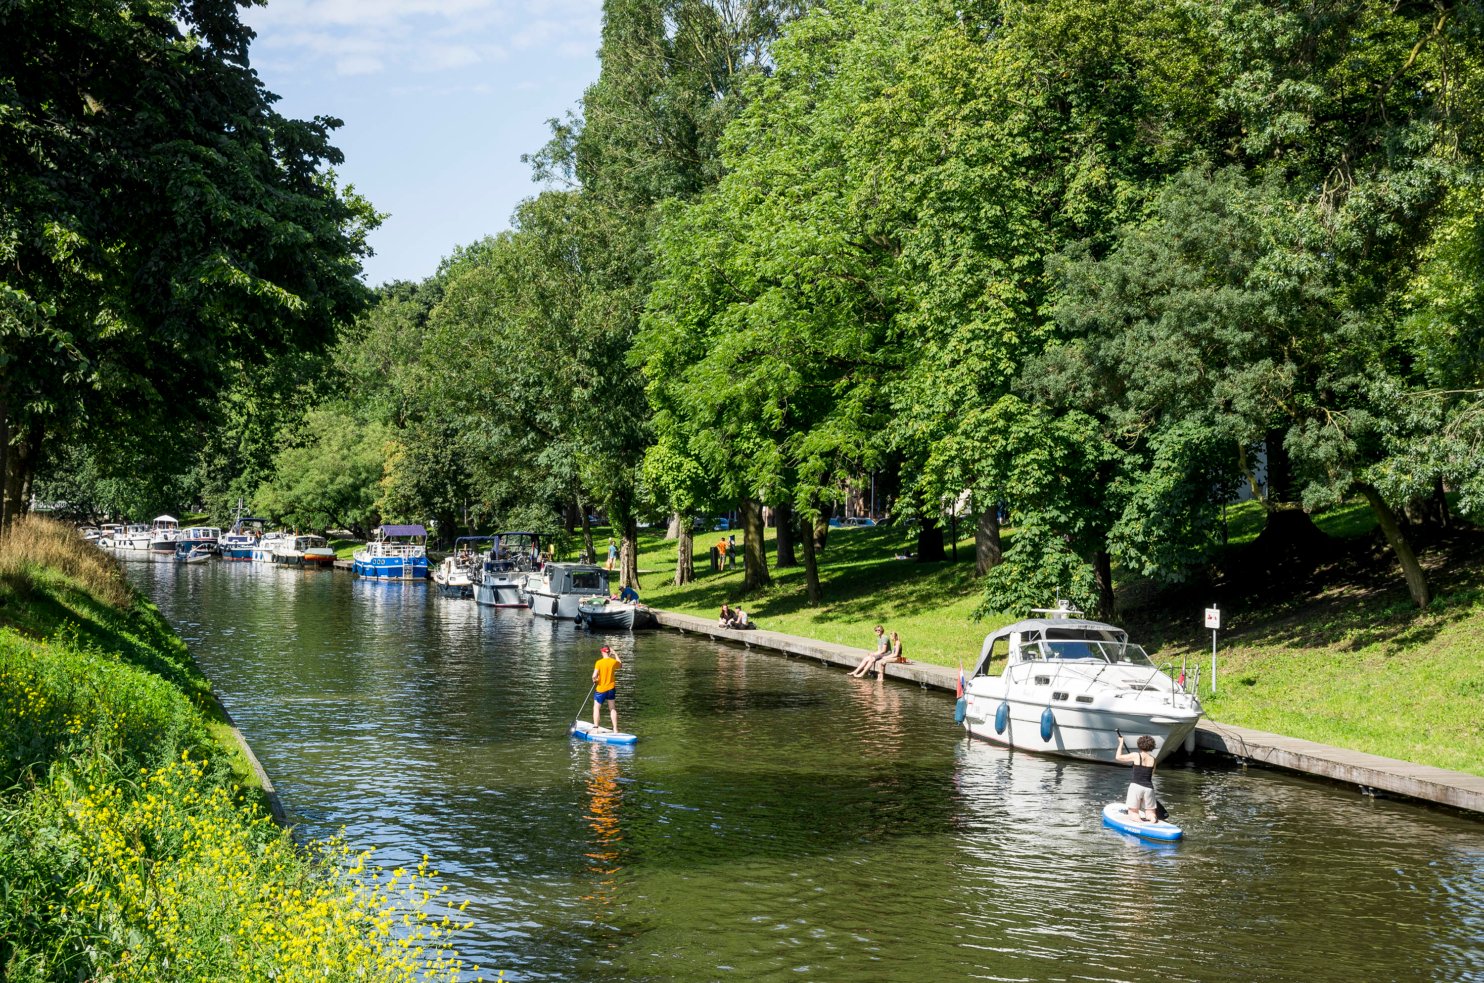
[965,604,1202,762]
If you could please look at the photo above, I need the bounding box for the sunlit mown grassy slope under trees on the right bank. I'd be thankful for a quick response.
[626,505,1484,775]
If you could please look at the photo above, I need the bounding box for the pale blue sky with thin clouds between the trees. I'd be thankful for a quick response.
[242,0,603,287]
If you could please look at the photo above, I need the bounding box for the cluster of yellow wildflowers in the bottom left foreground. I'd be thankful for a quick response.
[68,754,479,983]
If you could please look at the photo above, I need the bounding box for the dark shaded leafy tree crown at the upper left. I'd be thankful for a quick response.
[0,0,377,521]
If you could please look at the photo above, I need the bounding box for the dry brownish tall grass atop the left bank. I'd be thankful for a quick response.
[0,515,134,607]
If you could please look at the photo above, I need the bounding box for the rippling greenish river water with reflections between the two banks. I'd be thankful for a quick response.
[128,560,1484,982]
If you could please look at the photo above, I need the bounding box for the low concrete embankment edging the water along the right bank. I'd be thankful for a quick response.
[654,610,1484,814]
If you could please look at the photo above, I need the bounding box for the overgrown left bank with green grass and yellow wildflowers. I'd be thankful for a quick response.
[0,518,478,983]
